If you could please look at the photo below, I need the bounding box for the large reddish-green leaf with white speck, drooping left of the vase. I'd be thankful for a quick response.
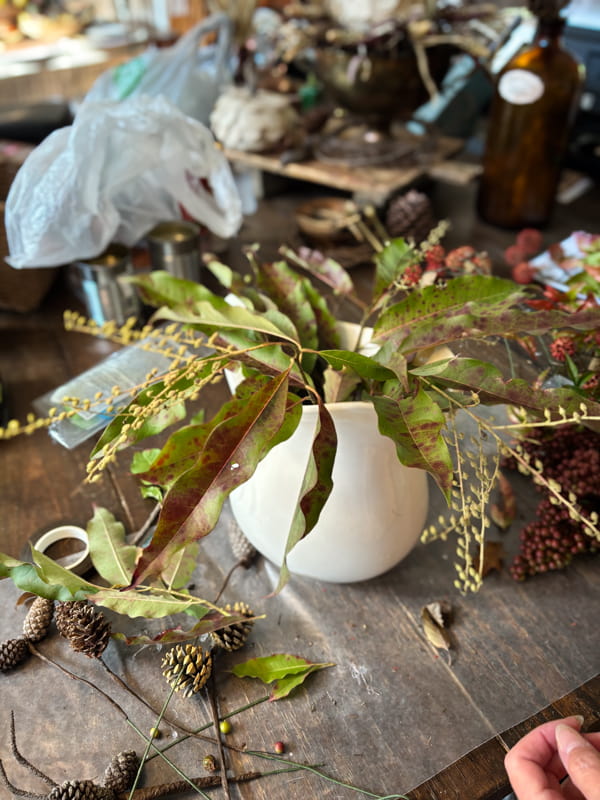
[134,372,300,585]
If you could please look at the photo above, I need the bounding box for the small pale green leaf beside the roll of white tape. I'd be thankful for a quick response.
[86,508,140,586]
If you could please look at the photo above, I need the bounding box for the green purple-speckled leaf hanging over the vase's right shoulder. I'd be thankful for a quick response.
[373,387,454,502]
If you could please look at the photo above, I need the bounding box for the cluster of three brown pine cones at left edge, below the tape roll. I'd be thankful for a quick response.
[0,597,110,672]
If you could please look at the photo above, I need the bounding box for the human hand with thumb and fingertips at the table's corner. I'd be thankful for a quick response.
[504,717,600,800]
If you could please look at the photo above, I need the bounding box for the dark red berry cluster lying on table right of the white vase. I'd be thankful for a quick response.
[506,426,600,581]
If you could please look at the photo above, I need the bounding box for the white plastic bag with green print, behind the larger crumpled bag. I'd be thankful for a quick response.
[83,14,232,125]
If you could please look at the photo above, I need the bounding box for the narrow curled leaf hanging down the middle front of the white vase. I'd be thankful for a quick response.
[275,400,337,592]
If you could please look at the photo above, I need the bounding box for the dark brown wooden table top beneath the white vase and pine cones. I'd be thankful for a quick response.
[0,184,600,800]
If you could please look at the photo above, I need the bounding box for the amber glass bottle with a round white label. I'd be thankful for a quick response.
[478,17,583,228]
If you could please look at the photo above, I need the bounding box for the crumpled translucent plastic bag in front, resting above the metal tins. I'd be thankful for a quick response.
[5,96,242,268]
